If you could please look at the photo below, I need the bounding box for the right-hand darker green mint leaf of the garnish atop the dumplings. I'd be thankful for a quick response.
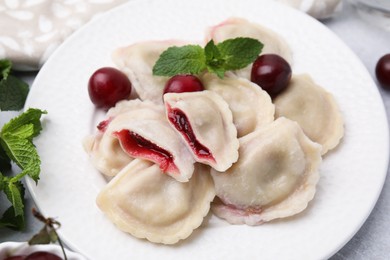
[217,37,264,70]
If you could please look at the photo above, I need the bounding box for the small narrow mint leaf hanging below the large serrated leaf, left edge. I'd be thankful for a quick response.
[4,180,24,217]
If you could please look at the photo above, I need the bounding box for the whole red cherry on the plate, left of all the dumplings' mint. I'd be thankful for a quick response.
[88,67,131,109]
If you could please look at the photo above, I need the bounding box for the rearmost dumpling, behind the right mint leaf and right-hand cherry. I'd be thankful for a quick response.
[206,18,292,79]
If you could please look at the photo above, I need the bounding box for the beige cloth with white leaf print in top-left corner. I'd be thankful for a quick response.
[0,0,126,70]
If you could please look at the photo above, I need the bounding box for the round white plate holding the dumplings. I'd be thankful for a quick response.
[27,0,389,260]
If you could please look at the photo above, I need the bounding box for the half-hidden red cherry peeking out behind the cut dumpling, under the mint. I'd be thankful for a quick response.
[164,75,204,94]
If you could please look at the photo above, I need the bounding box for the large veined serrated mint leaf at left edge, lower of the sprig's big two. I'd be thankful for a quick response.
[0,133,41,183]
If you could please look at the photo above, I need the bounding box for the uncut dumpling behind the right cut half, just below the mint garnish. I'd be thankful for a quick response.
[202,74,275,137]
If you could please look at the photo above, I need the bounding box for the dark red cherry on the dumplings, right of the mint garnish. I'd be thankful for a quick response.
[251,54,292,97]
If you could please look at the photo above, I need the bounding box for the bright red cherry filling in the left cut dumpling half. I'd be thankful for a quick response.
[114,129,179,173]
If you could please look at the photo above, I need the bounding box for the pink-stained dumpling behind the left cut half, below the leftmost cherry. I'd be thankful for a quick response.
[84,99,164,176]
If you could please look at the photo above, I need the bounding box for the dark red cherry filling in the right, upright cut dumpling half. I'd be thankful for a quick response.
[168,106,215,162]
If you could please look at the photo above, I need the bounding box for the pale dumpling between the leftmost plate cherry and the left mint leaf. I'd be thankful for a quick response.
[112,41,183,104]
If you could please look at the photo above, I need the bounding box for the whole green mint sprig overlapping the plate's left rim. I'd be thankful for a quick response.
[0,108,46,230]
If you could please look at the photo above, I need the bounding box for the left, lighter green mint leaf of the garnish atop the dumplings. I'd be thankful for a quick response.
[153,45,206,76]
